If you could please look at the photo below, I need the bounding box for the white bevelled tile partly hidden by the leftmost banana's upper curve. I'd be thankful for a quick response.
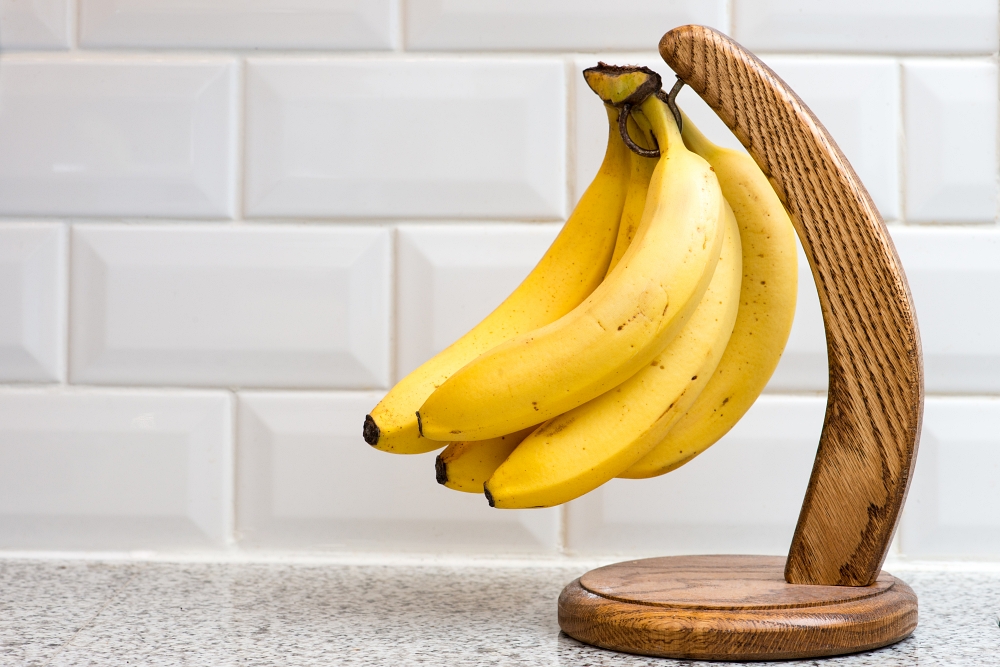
[396,224,561,377]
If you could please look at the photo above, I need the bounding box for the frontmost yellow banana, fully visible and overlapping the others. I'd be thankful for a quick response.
[417,96,725,440]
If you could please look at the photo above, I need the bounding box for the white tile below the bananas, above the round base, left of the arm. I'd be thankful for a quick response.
[567,395,826,555]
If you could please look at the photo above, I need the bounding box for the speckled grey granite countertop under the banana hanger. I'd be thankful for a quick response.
[0,558,1000,667]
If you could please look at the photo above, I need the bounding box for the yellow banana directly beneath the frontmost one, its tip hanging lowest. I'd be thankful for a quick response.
[485,205,742,509]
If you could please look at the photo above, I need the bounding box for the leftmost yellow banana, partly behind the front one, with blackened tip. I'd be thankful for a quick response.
[364,105,630,454]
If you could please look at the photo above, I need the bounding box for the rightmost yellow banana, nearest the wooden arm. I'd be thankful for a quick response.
[620,108,798,478]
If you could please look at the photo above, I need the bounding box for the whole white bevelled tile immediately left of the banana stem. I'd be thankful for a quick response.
[246,57,566,219]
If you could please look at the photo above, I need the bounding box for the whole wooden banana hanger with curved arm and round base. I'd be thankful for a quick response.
[559,25,923,660]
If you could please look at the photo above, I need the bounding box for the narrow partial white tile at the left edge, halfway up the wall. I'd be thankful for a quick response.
[0,223,66,382]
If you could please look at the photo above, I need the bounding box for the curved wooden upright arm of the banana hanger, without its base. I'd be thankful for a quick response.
[660,25,923,586]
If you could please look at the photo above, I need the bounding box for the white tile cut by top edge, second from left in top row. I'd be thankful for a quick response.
[80,0,395,49]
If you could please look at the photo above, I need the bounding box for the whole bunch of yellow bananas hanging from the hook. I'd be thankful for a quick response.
[364,63,797,509]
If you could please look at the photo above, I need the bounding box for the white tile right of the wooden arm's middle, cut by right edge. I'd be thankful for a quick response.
[892,227,1000,394]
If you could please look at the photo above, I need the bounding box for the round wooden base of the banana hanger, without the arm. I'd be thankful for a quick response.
[559,556,917,660]
